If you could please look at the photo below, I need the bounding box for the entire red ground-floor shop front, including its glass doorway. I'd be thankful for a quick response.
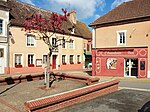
[92,47,148,78]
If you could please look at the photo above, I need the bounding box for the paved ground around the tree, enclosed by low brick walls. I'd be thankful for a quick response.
[0,80,86,112]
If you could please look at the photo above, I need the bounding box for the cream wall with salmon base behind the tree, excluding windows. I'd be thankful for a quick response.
[6,27,83,73]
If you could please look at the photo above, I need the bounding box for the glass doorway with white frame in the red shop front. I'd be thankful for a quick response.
[125,59,138,77]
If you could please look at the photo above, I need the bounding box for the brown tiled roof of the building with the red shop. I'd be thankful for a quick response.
[89,0,150,26]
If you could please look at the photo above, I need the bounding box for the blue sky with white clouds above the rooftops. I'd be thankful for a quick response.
[18,0,129,25]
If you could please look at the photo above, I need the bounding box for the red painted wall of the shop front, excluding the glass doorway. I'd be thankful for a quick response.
[92,47,148,78]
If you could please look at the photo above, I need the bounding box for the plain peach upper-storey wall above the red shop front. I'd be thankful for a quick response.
[96,21,150,76]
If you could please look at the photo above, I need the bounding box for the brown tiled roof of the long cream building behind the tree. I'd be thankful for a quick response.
[8,0,92,39]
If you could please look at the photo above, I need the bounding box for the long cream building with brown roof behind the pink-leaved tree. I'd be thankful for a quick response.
[5,0,92,74]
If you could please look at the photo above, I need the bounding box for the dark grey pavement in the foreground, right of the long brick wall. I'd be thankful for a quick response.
[56,89,150,112]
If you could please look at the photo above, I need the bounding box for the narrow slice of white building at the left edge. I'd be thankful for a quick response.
[0,0,9,74]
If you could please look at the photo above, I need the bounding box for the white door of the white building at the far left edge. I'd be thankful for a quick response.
[0,48,5,74]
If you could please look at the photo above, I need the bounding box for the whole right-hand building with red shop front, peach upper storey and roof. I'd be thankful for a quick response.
[89,0,150,78]
